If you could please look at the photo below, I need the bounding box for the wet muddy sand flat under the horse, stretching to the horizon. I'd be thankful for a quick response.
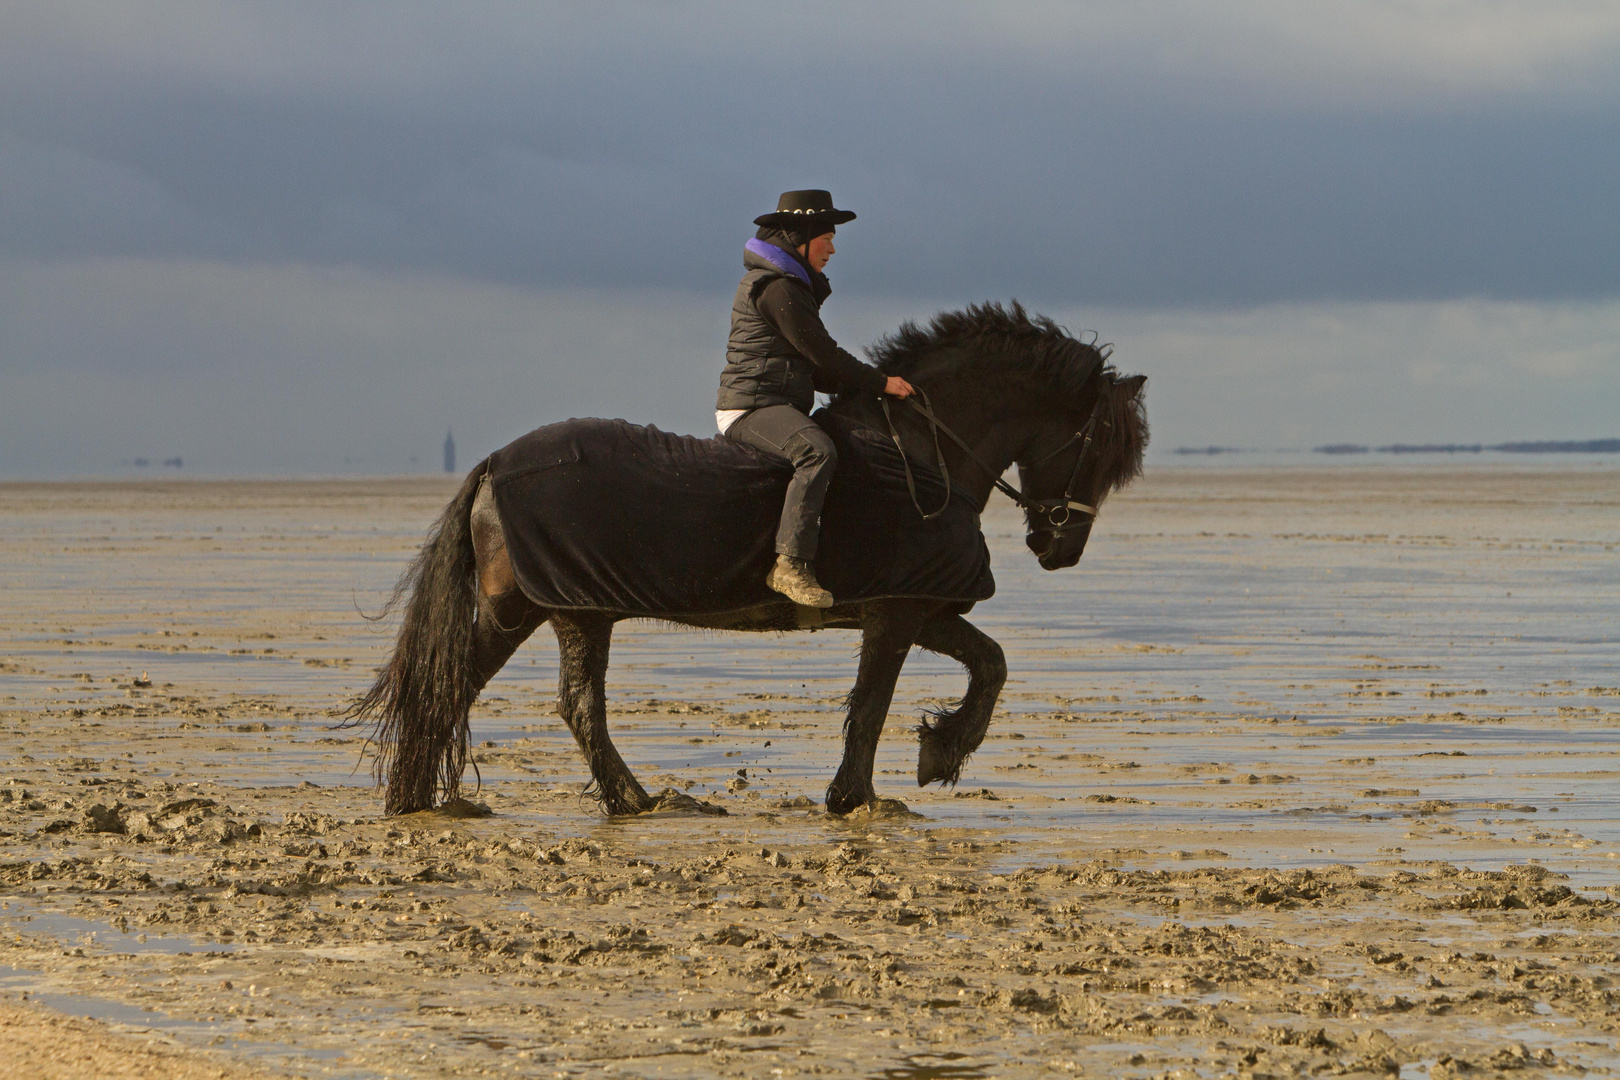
[0,468,1620,1078]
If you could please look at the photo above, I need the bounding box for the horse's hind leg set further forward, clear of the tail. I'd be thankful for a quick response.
[551,612,653,814]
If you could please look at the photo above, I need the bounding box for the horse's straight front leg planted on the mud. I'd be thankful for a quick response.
[826,601,936,814]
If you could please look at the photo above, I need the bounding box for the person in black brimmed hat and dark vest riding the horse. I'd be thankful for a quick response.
[714,189,912,607]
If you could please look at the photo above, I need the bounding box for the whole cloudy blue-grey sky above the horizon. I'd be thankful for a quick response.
[0,0,1620,478]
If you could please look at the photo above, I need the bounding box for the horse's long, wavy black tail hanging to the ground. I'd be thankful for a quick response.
[343,461,488,814]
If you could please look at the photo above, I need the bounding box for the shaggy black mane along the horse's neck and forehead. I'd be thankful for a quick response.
[867,300,1147,491]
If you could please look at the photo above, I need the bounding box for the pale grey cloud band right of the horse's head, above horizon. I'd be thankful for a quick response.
[1075,301,1620,450]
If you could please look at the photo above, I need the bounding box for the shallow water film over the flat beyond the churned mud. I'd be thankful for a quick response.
[0,463,1620,882]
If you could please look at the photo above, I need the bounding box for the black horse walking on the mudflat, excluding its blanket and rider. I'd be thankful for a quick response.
[348,303,1147,814]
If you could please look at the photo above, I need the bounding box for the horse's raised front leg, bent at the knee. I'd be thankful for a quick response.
[917,615,1008,787]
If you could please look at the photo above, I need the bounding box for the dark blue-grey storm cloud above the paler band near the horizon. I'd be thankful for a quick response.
[0,3,1620,306]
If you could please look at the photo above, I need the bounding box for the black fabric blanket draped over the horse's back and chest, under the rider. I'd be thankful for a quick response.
[489,411,995,615]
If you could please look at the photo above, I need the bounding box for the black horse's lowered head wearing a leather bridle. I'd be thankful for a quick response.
[1017,368,1147,570]
